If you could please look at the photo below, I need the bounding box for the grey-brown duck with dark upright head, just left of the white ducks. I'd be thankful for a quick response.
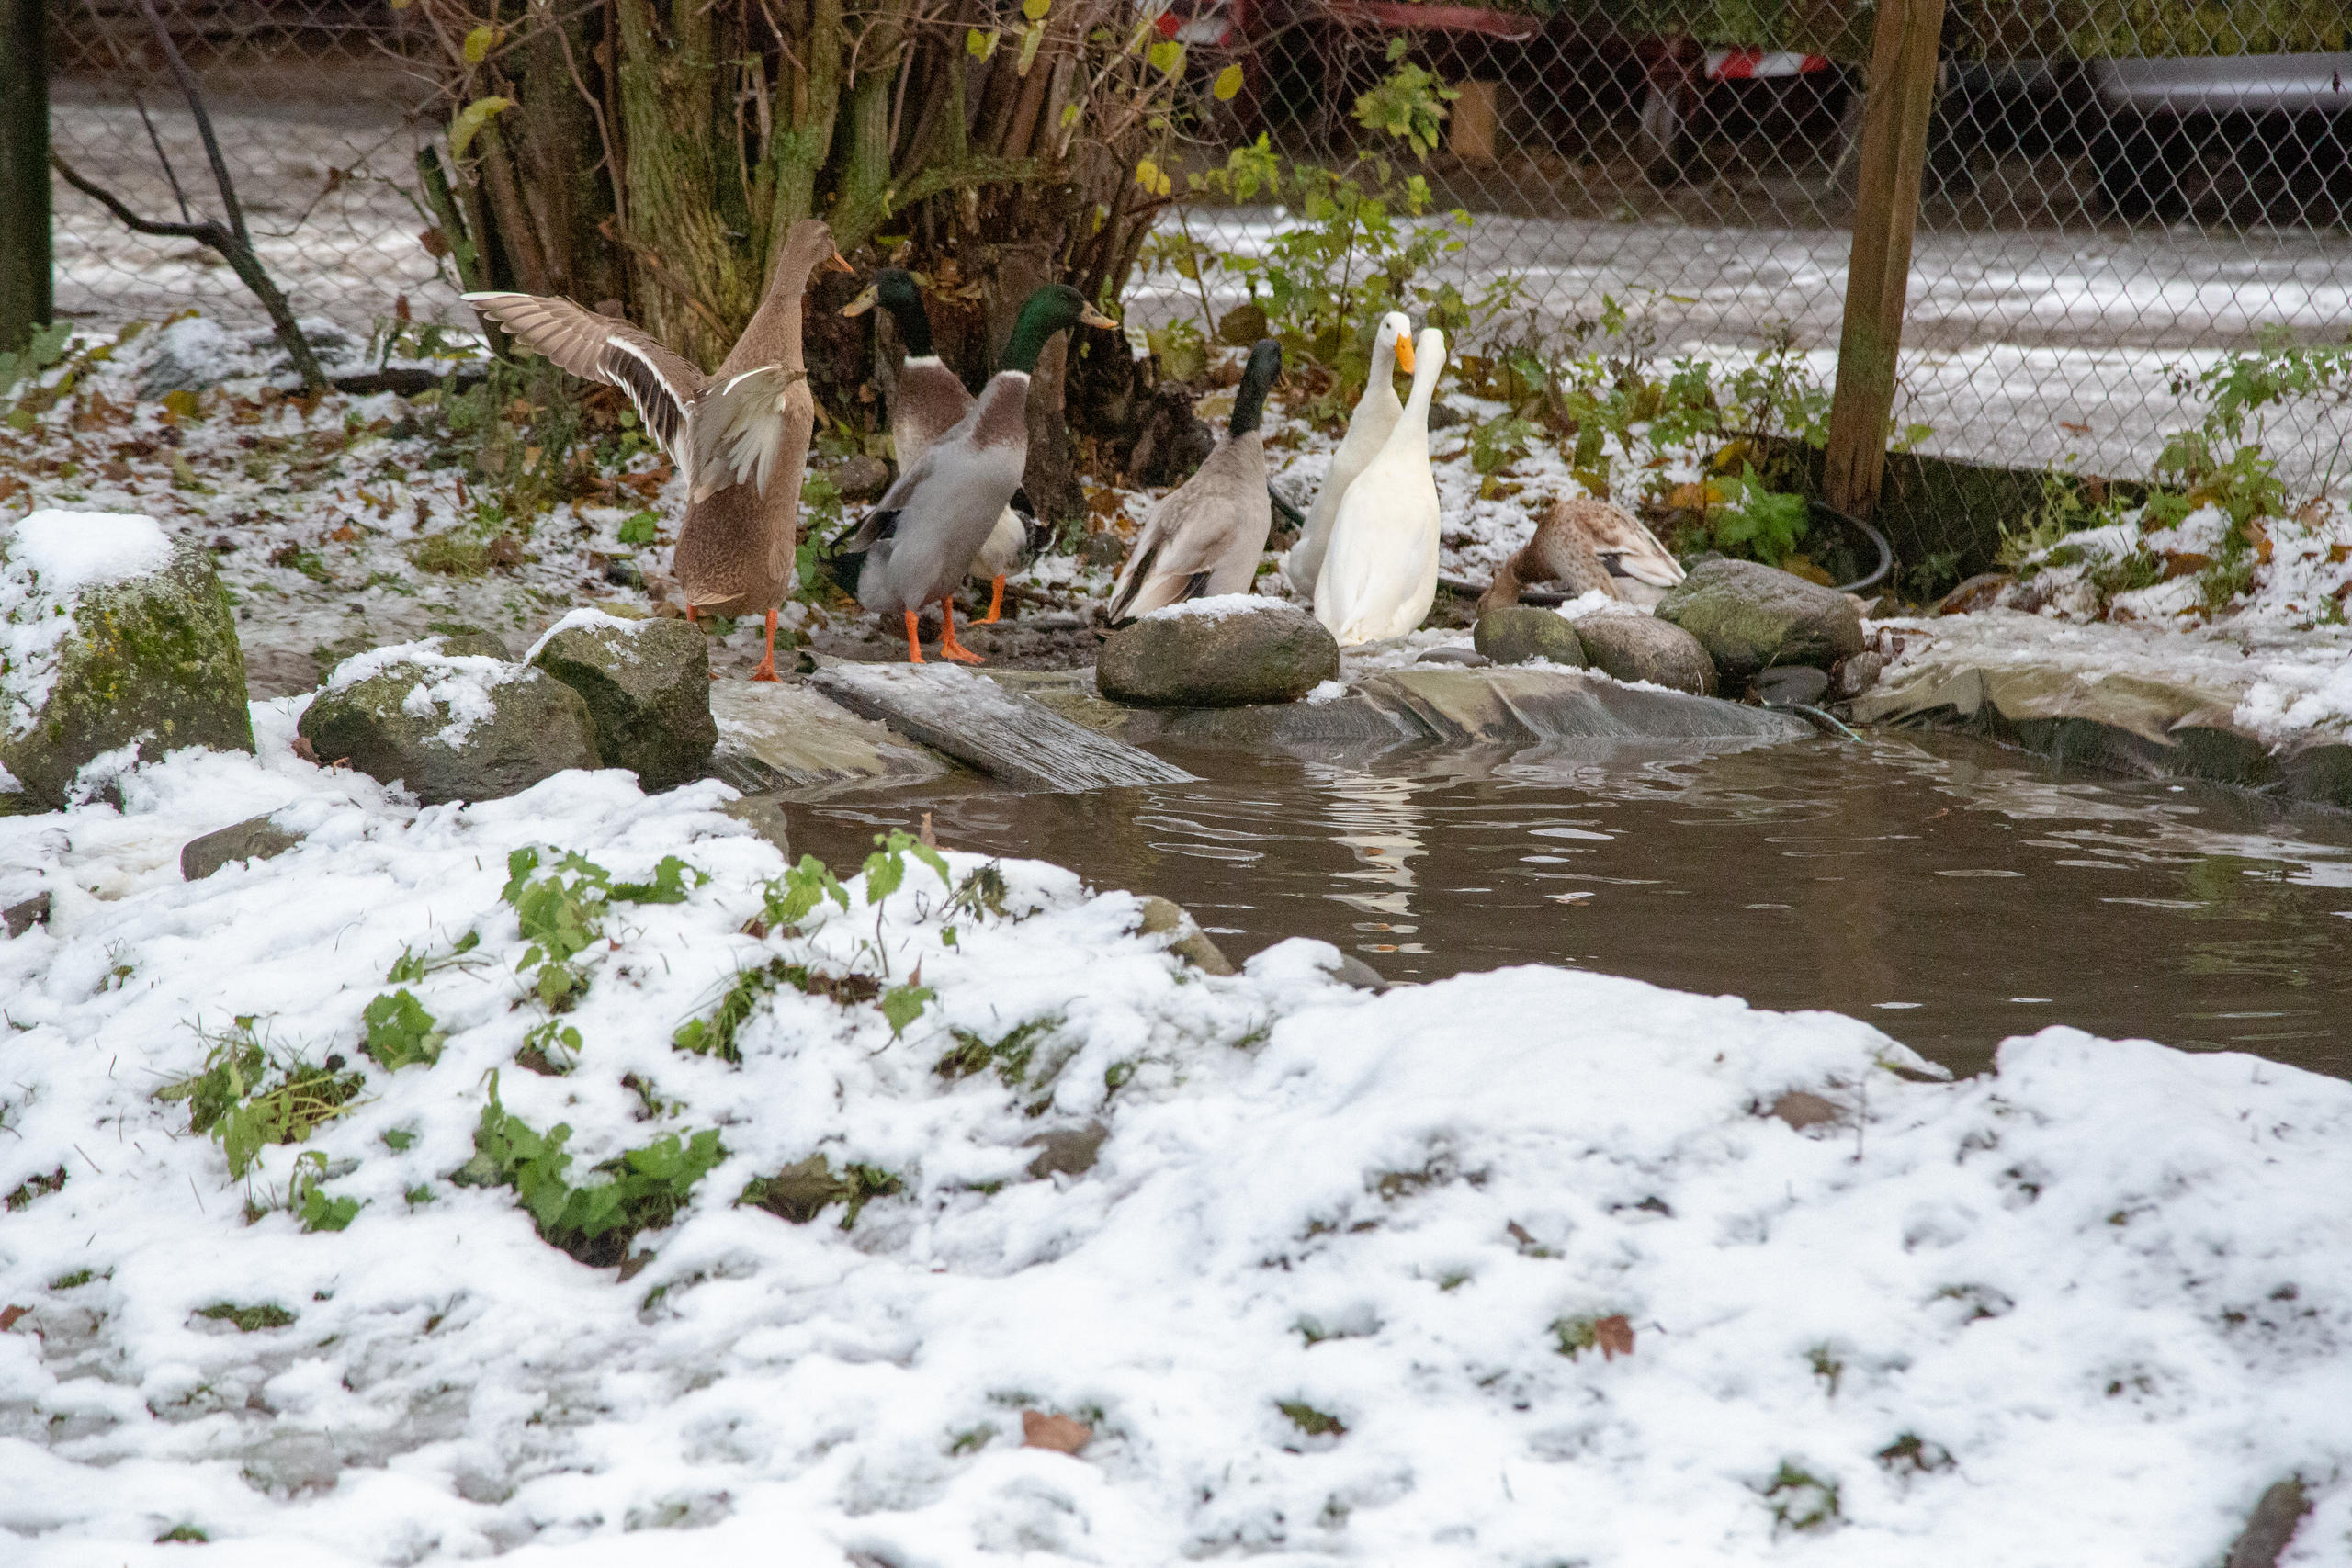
[1108,339,1282,627]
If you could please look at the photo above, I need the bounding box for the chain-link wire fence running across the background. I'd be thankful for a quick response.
[37,0,2352,569]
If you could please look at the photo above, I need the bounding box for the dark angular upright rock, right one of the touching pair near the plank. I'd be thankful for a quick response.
[532,609,719,795]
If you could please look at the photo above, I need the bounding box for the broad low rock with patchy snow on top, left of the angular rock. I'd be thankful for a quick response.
[299,642,602,807]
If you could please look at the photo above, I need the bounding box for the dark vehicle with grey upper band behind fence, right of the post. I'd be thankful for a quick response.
[2084,54,2352,228]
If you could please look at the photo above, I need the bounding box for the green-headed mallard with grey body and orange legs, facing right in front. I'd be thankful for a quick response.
[847,282,1117,665]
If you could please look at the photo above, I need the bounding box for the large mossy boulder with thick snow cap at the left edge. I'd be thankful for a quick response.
[0,510,254,808]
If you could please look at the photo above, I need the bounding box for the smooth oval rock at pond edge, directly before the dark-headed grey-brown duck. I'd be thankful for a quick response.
[1093,594,1339,707]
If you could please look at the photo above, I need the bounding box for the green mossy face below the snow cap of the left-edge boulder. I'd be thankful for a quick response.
[0,541,254,808]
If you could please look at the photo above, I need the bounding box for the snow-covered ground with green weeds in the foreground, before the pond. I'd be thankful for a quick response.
[0,719,2352,1568]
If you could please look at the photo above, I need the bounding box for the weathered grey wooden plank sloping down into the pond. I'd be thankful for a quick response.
[809,663,1193,792]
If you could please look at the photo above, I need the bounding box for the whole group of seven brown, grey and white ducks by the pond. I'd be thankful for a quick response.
[466,219,1681,682]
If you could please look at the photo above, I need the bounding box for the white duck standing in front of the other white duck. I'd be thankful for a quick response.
[1315,327,1446,647]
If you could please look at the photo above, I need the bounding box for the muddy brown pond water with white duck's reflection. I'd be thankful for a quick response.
[788,731,2352,1077]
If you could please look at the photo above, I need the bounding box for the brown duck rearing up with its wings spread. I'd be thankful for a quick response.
[466,219,854,682]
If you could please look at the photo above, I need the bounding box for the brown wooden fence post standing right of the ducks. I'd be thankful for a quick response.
[1823,0,1943,517]
